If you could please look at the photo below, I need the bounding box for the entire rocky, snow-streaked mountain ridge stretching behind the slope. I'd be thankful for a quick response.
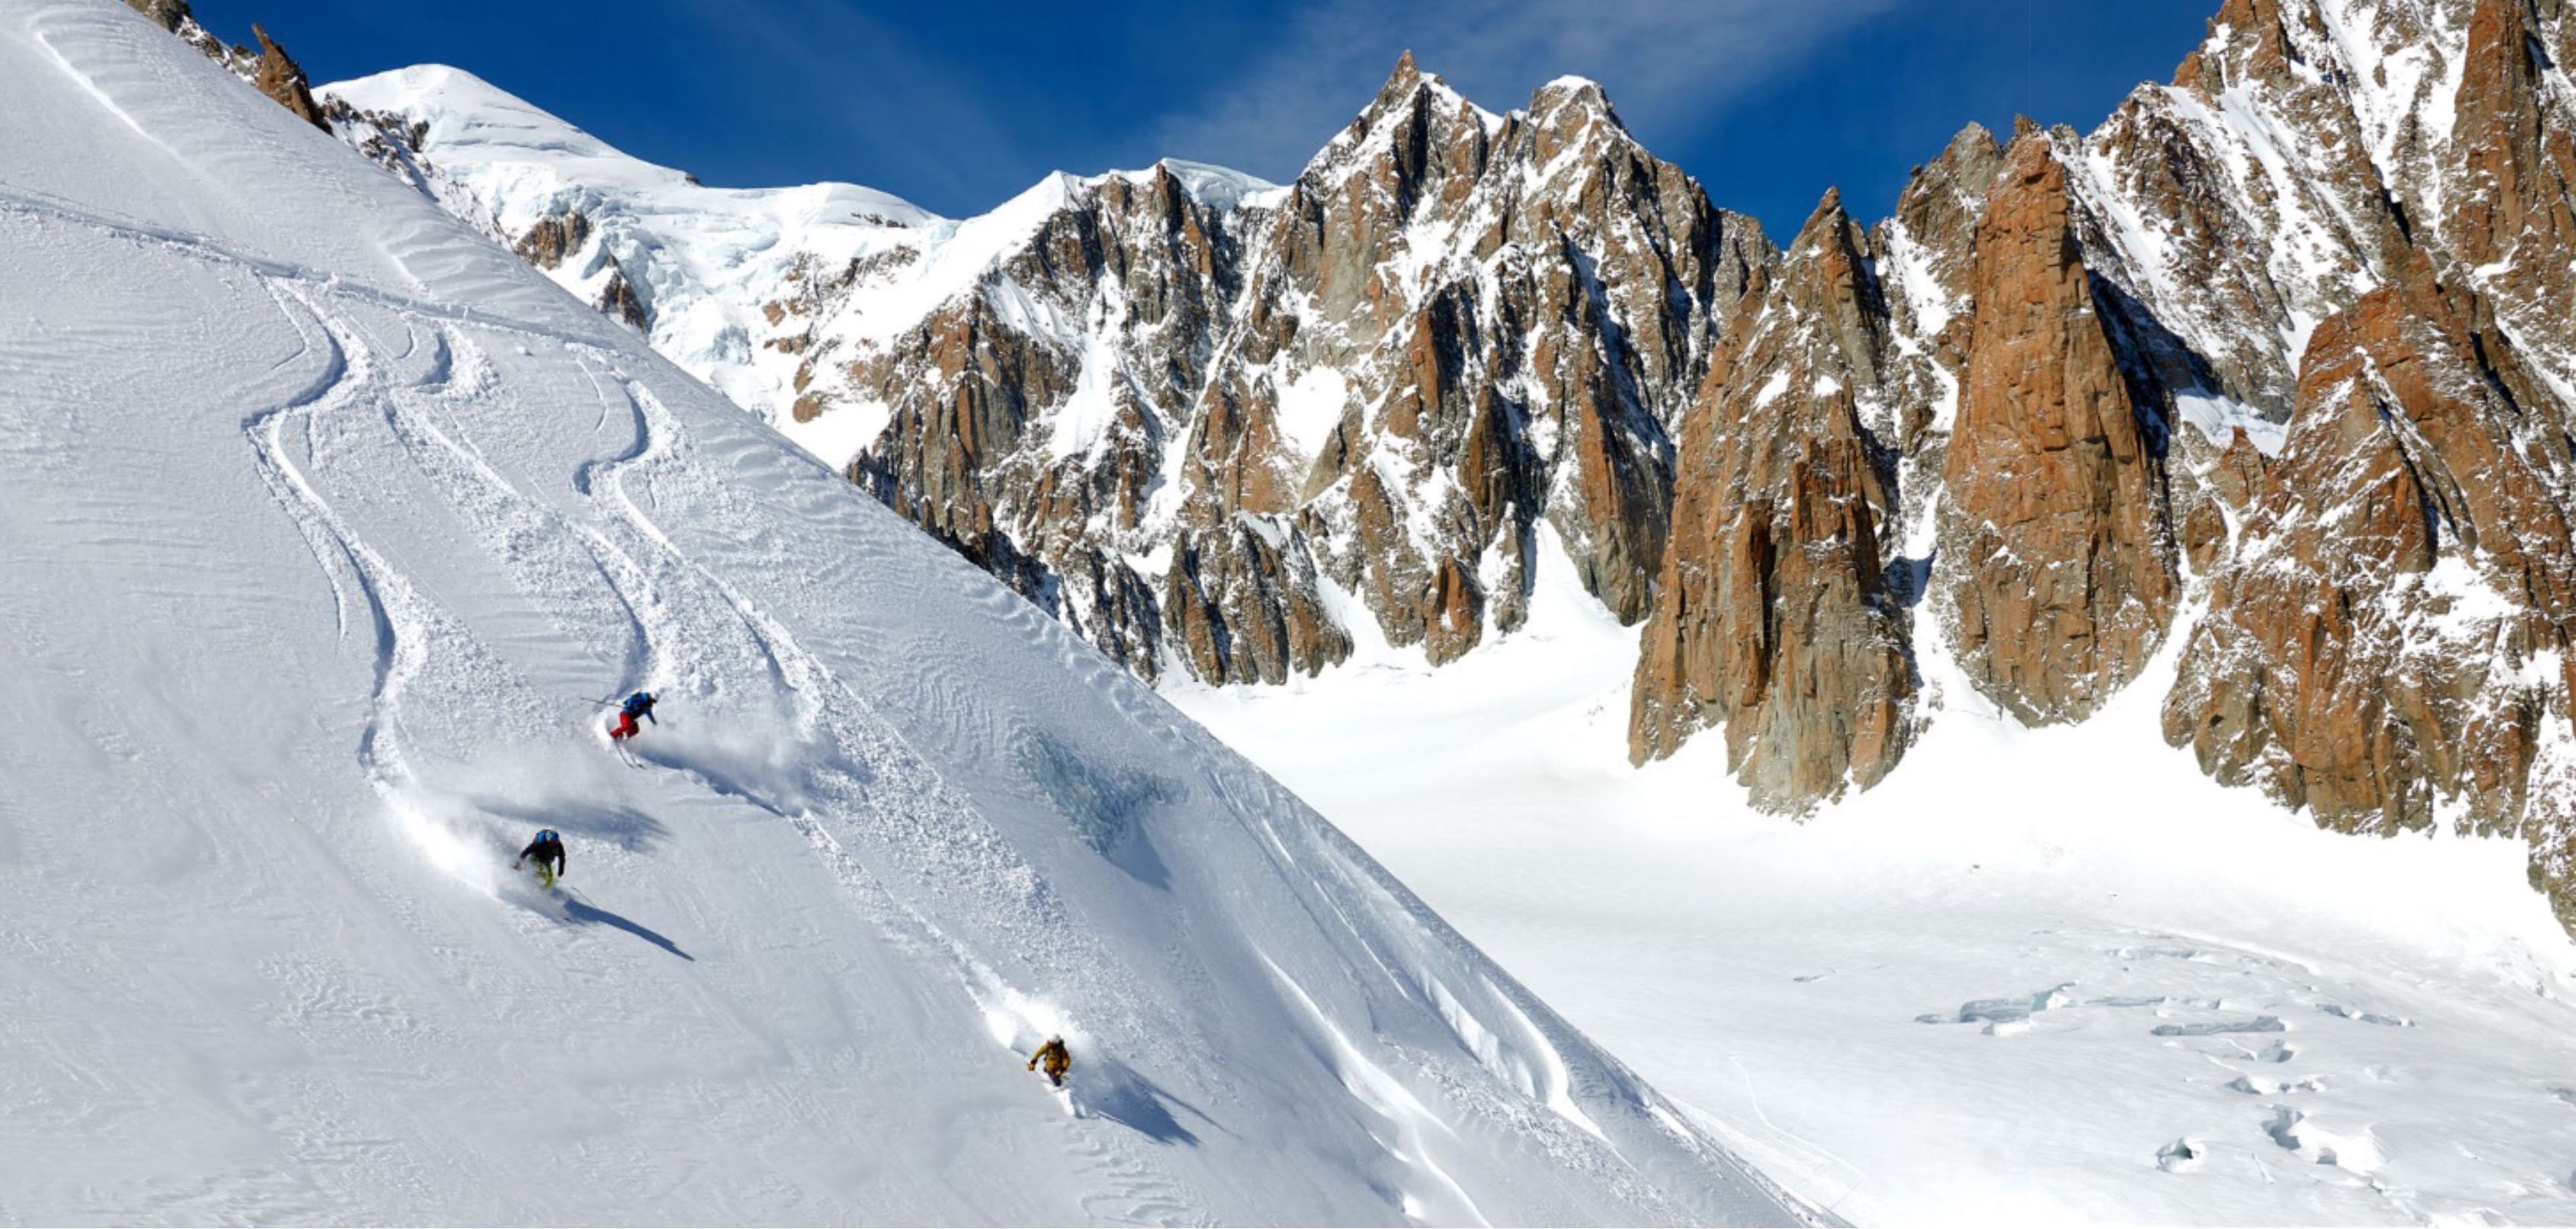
[125,0,2576,917]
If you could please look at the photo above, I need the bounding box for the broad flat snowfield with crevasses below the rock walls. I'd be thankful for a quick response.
[1167,543,2576,1224]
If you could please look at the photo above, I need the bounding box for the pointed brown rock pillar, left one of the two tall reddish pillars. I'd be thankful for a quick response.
[1628,196,1914,809]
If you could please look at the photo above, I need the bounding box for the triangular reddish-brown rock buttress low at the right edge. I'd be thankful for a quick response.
[2164,260,2576,917]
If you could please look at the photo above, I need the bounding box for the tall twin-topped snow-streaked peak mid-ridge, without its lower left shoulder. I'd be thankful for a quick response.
[1185,59,1770,662]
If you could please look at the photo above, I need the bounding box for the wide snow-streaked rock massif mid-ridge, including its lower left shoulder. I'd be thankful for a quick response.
[773,59,1773,683]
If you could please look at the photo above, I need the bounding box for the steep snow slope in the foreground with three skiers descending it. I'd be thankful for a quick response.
[0,0,1803,1224]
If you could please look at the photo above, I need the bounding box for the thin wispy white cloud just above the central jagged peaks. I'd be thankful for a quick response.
[1162,0,1906,178]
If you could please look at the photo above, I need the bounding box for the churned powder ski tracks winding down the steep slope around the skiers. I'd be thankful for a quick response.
[229,258,1203,1224]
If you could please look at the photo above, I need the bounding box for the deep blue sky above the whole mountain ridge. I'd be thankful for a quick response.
[196,0,2218,242]
